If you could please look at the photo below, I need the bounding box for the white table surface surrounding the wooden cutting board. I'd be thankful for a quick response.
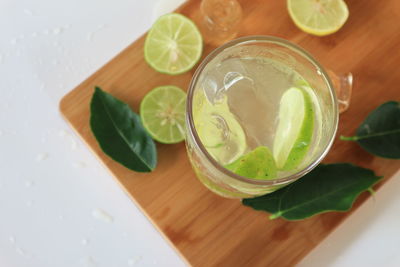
[0,0,400,267]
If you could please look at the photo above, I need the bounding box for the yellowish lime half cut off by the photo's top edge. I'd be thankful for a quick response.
[287,0,349,36]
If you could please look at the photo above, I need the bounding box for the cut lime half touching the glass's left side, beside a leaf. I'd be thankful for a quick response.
[140,85,186,144]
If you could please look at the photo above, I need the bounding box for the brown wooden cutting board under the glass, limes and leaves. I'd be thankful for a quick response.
[60,0,400,267]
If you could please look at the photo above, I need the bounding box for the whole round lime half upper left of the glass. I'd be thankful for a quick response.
[144,13,203,75]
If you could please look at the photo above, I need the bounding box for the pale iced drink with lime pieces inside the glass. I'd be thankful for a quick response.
[193,47,321,182]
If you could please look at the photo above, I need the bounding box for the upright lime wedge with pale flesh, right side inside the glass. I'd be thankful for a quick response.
[273,87,314,170]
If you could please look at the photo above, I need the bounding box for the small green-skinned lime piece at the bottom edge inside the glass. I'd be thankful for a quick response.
[225,146,277,180]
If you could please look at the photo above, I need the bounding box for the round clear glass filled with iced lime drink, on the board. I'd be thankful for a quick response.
[186,36,338,198]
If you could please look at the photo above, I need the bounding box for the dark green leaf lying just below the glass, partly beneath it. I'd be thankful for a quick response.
[242,163,382,220]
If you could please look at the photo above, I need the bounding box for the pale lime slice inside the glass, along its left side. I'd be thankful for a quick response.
[193,92,247,165]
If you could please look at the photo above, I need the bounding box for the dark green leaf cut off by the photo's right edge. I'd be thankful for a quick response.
[340,101,400,159]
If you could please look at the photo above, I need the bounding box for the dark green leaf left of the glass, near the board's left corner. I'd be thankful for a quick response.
[90,87,157,172]
